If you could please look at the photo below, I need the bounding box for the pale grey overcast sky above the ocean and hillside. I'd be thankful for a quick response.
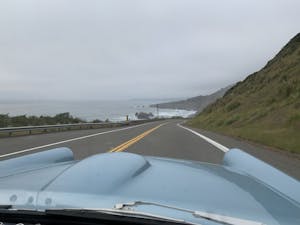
[0,0,300,100]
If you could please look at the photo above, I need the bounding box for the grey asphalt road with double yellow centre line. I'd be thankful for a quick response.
[0,120,300,180]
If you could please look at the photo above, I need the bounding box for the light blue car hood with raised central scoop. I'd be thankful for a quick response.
[0,149,300,225]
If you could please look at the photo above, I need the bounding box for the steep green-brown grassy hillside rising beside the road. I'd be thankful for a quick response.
[188,33,300,153]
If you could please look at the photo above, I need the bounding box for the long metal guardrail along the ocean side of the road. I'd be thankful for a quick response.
[0,120,153,137]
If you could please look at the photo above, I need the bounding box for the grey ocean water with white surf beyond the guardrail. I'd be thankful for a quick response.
[0,100,195,121]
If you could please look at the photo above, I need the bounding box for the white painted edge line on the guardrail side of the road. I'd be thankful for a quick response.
[0,123,157,158]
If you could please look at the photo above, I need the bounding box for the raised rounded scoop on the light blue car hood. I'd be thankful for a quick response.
[44,152,150,194]
